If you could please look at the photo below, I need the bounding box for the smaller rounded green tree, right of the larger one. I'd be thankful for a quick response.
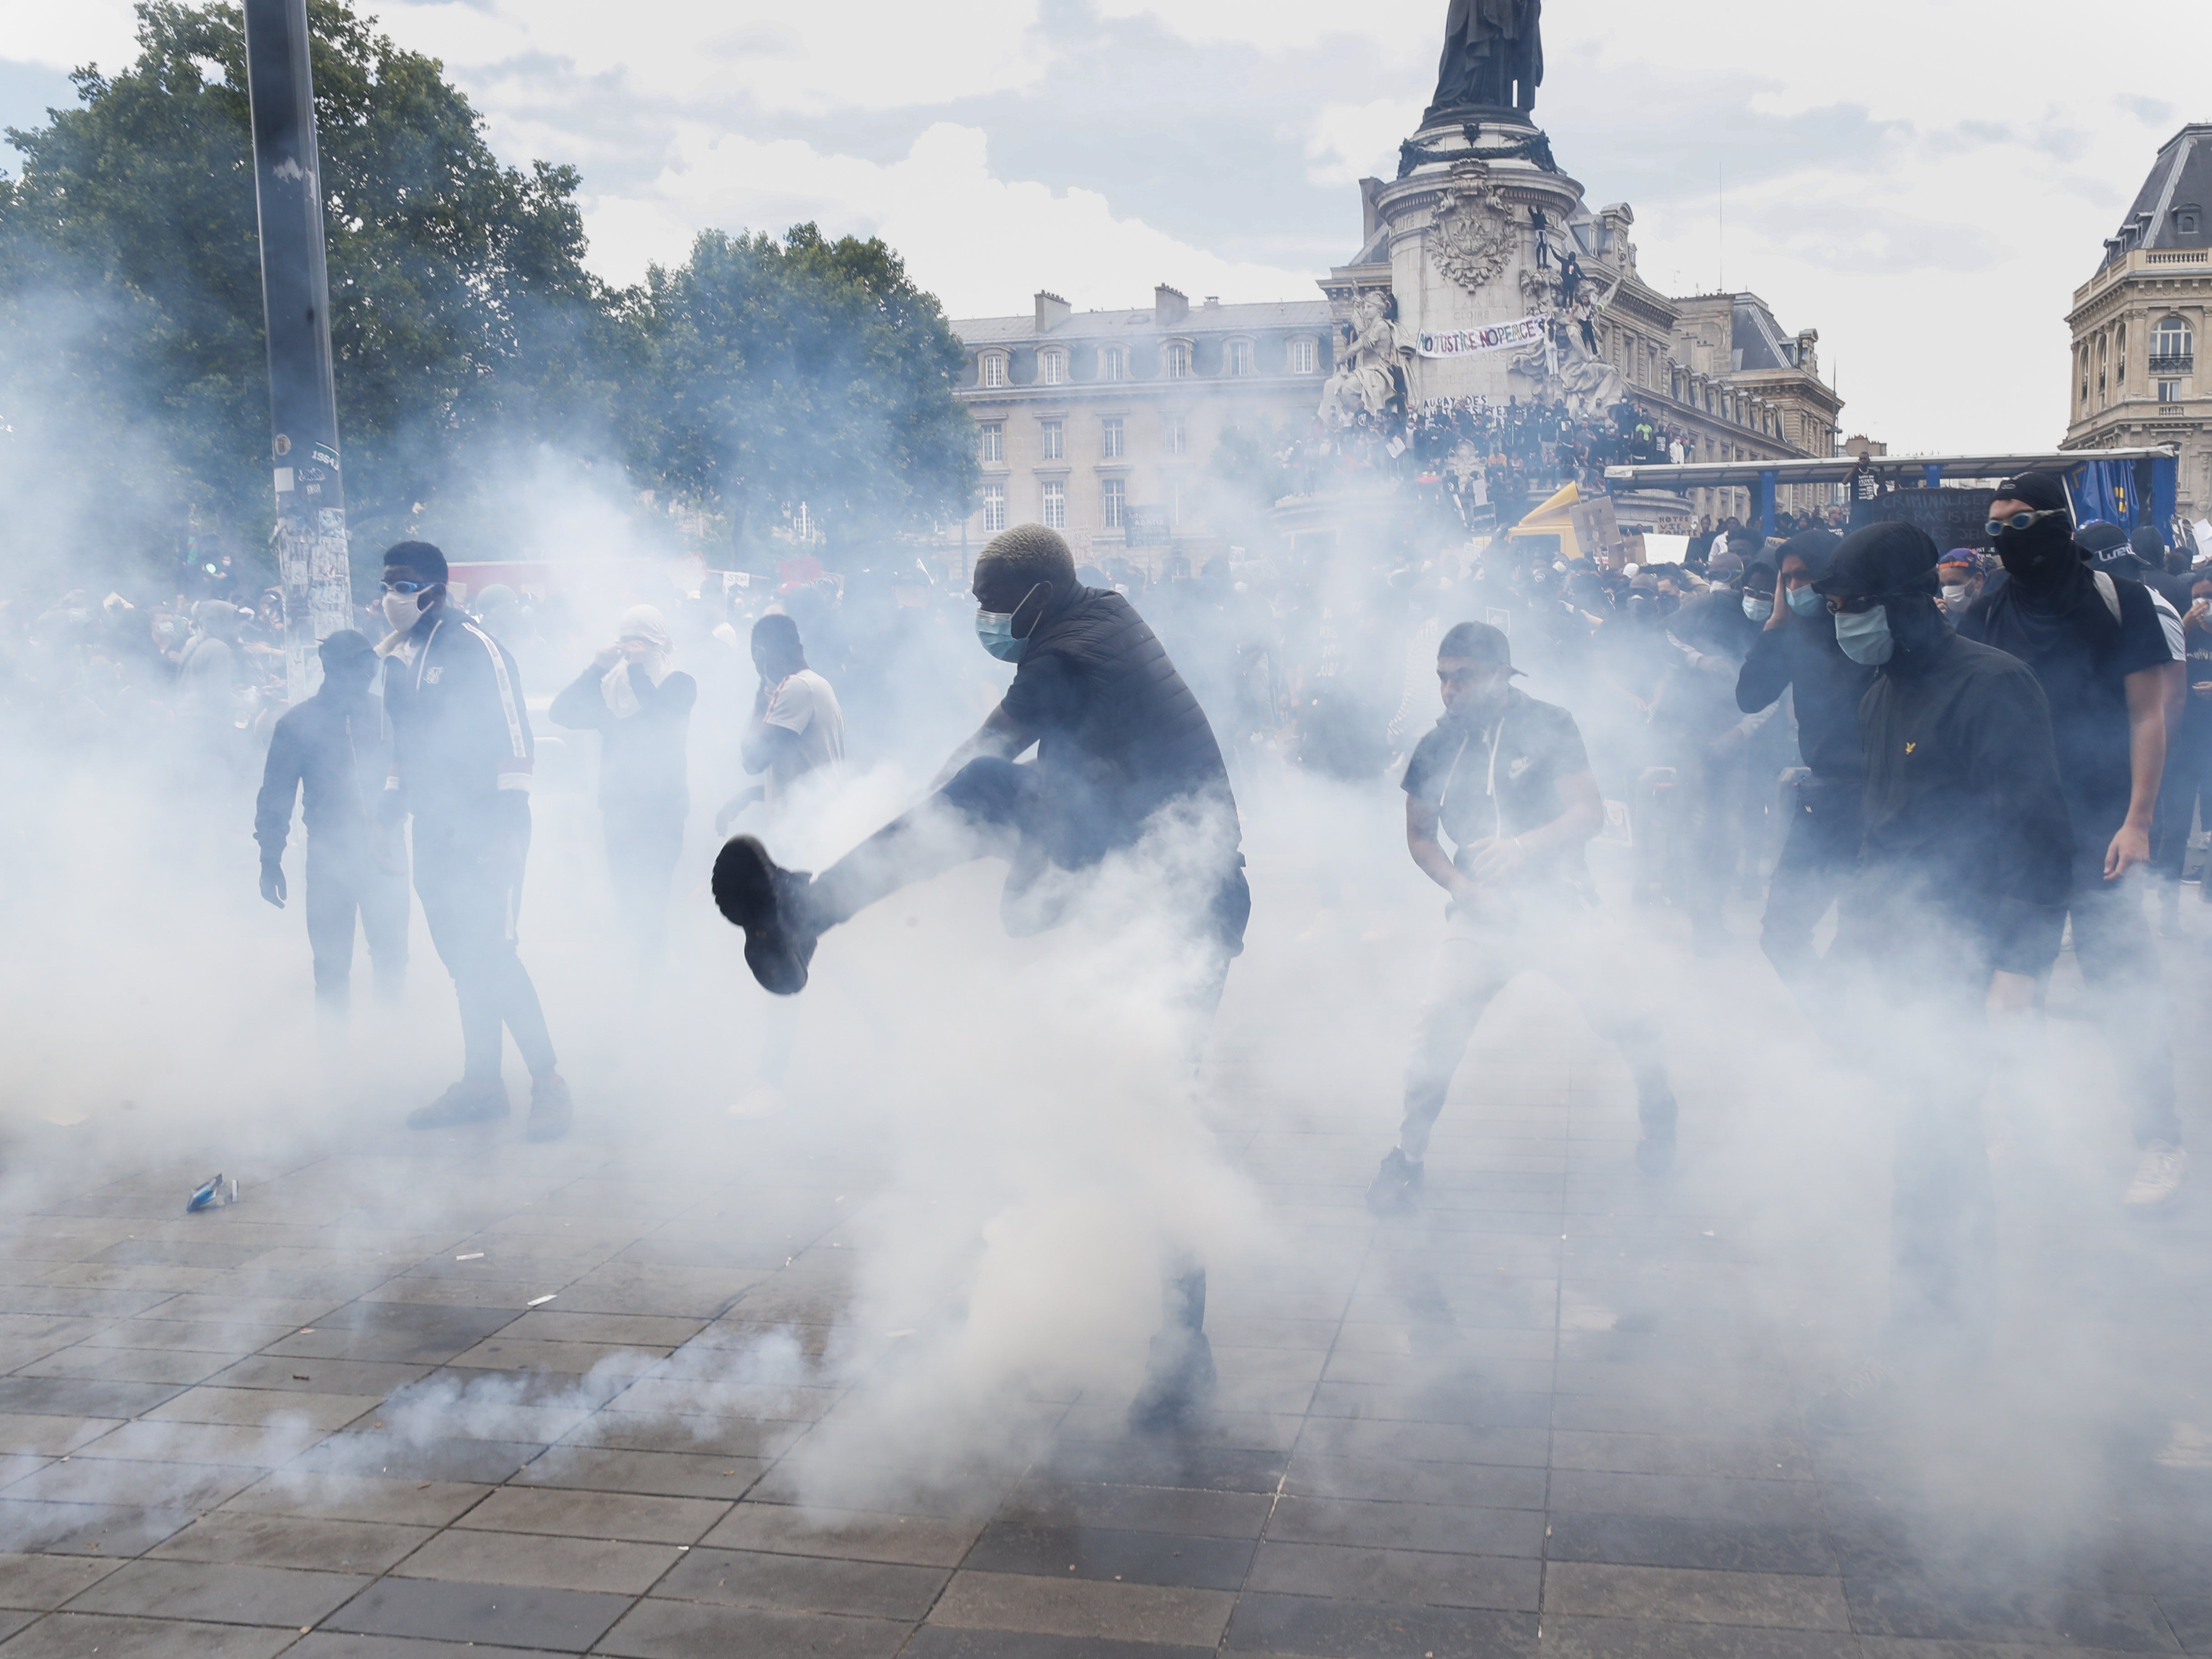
[626,223,978,562]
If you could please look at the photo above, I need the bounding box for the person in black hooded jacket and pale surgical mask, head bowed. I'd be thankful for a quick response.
[1812,524,2075,1429]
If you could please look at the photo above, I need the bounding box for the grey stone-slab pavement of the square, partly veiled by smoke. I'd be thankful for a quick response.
[0,902,2212,1659]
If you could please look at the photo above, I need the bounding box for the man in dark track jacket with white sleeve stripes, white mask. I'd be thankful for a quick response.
[376,542,571,1141]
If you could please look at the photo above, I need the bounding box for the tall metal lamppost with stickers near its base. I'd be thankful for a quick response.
[246,0,354,703]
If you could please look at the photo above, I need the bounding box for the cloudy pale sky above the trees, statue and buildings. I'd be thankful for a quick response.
[0,0,2212,451]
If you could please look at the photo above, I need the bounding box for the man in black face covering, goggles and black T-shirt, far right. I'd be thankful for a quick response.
[1958,474,2188,1208]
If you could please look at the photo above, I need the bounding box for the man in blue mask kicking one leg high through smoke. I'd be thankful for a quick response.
[715,524,1252,1429]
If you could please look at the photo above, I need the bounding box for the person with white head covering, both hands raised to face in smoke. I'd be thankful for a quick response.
[551,604,699,969]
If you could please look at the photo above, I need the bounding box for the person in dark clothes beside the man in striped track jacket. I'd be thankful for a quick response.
[254,628,407,1024]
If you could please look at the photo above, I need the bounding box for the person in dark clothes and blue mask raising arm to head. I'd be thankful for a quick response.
[1736,531,1874,1013]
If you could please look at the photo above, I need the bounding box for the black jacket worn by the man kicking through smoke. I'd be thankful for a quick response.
[1004,586,1236,852]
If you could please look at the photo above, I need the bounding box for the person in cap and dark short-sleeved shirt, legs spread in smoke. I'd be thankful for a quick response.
[1367,621,1674,1216]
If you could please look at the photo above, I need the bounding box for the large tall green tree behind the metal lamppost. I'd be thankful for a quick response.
[0,0,626,575]
